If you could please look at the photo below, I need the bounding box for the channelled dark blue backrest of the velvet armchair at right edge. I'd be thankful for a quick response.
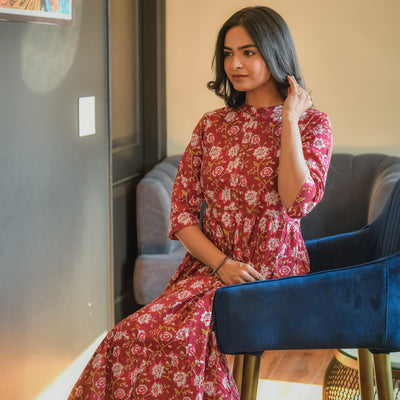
[371,179,400,259]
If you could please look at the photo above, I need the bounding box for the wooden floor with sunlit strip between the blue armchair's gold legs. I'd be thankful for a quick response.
[228,350,334,400]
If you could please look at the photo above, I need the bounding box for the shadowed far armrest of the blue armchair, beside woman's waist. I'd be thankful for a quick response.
[306,225,376,272]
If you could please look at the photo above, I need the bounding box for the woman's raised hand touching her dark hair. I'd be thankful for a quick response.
[282,76,312,121]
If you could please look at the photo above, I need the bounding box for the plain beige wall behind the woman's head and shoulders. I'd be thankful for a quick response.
[166,0,400,156]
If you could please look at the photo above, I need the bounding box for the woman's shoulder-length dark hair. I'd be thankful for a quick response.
[207,6,304,108]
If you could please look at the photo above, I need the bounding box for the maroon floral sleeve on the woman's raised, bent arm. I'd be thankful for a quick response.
[287,112,332,218]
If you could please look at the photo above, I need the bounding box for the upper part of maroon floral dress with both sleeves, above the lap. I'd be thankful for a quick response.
[170,105,331,279]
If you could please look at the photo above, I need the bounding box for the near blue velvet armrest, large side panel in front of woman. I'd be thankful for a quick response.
[213,253,400,354]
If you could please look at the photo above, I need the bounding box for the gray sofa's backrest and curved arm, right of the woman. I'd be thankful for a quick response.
[301,153,400,240]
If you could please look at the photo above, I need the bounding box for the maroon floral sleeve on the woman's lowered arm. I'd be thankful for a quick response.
[169,117,205,240]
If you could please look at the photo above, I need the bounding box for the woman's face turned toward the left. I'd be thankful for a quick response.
[224,26,276,94]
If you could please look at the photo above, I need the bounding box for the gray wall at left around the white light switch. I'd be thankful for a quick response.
[0,0,110,400]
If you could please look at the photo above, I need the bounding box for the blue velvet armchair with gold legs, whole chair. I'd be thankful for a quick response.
[213,180,400,400]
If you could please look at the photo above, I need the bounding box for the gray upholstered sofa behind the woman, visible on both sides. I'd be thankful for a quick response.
[133,153,400,305]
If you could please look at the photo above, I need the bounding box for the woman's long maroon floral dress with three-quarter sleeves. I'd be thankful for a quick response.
[69,105,331,400]
